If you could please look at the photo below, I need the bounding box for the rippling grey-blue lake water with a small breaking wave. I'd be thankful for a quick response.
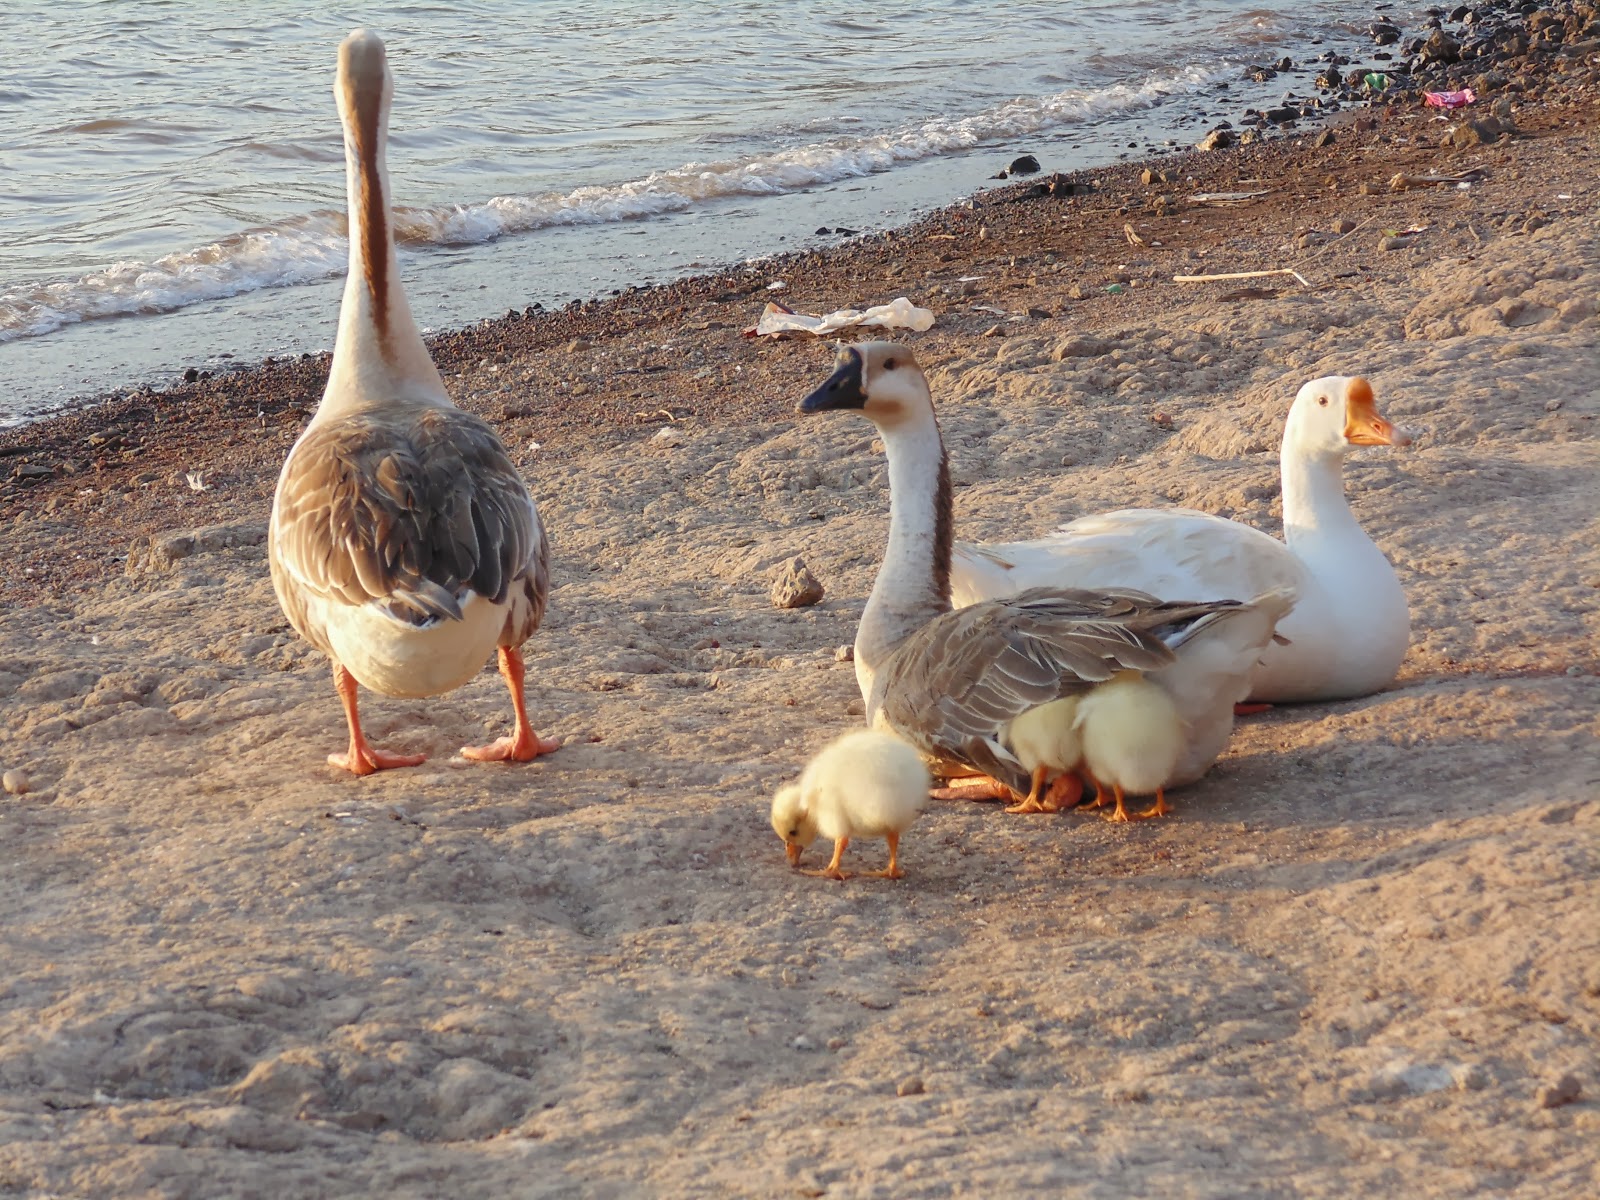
[0,0,1370,422]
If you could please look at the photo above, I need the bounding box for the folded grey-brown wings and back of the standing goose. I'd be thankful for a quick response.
[270,408,549,632]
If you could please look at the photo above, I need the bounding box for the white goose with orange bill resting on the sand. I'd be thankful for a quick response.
[950,376,1411,702]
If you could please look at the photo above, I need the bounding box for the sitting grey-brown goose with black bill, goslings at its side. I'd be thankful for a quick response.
[798,342,1294,819]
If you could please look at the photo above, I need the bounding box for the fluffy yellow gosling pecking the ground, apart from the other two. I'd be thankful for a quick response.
[773,730,930,880]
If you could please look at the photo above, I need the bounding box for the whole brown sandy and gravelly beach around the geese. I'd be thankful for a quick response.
[0,21,1600,1200]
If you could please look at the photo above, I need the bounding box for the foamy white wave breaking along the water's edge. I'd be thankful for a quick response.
[0,69,1213,342]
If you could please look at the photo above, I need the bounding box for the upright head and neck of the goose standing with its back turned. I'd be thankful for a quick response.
[323,51,450,408]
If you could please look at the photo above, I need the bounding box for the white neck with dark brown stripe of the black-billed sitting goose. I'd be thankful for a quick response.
[856,413,954,693]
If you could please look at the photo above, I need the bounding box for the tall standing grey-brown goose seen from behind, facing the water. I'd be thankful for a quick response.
[267,29,560,774]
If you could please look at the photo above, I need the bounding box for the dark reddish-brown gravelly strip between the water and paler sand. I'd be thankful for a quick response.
[12,31,1597,603]
